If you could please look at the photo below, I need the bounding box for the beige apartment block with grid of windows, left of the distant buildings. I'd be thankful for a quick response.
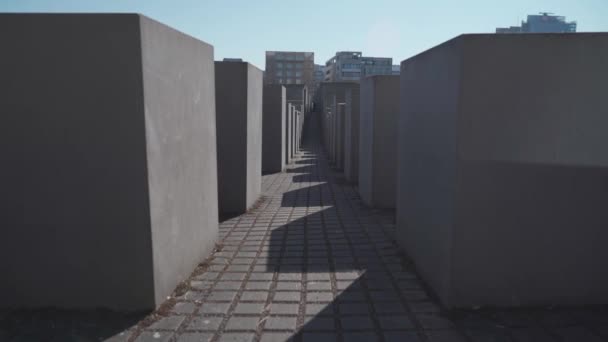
[264,51,315,89]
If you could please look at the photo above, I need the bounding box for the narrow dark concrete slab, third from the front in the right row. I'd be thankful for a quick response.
[344,85,360,183]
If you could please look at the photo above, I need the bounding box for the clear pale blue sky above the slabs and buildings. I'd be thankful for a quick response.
[0,0,608,69]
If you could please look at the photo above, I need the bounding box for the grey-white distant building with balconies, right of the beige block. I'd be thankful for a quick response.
[323,51,393,82]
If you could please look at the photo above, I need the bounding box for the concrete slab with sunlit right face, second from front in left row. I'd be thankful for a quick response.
[215,62,263,215]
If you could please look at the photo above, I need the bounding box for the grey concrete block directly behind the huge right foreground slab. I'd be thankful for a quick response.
[358,75,399,208]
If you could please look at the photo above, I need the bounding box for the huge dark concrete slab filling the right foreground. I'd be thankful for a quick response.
[397,33,608,307]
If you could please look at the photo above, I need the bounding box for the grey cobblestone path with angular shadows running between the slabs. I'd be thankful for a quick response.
[132,113,608,342]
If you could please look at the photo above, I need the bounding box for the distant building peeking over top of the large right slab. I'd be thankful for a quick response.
[496,13,576,33]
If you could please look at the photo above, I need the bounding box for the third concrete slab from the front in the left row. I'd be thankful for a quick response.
[262,85,287,173]
